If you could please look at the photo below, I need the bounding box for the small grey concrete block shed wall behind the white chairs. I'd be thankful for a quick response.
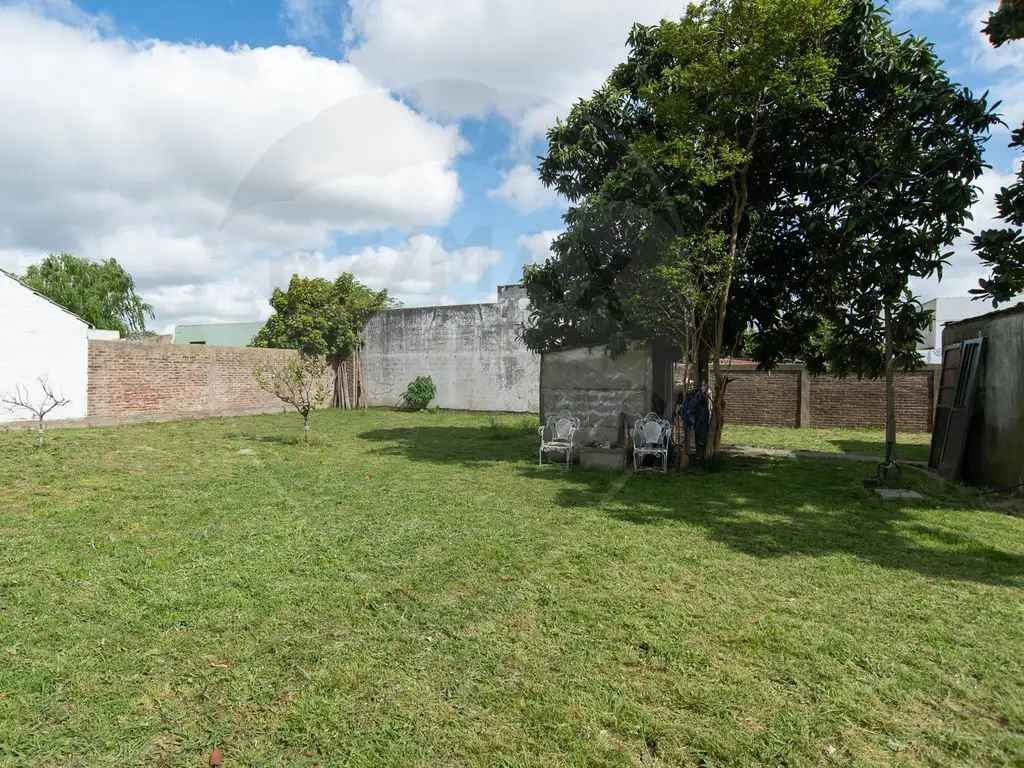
[541,347,652,444]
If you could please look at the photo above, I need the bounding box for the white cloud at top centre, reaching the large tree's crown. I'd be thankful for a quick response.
[346,0,687,143]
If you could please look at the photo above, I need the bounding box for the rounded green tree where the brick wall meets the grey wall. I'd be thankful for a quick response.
[251,272,397,408]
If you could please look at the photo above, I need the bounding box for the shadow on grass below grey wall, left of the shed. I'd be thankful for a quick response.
[359,424,538,464]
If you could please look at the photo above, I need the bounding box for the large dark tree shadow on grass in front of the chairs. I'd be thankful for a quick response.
[522,457,1024,587]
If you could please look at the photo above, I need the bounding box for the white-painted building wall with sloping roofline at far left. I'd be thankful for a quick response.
[0,272,89,422]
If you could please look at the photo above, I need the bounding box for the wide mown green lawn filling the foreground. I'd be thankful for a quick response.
[0,412,1024,768]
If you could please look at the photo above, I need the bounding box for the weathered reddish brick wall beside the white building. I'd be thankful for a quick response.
[88,341,333,425]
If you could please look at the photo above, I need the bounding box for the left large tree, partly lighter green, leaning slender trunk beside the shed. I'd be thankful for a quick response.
[524,0,840,453]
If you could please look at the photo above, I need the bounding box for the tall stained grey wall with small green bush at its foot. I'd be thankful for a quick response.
[362,286,541,414]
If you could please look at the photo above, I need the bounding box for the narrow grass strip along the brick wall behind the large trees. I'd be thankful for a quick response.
[723,424,932,462]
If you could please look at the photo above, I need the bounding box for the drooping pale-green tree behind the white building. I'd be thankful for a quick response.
[22,253,154,337]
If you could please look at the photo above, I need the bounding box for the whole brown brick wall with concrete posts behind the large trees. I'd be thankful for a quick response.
[726,366,938,432]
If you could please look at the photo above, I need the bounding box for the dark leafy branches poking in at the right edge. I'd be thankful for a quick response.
[972,0,1024,306]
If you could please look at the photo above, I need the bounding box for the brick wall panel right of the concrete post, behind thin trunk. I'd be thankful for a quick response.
[811,370,934,432]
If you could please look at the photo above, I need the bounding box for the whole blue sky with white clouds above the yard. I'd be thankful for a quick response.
[0,0,1024,330]
